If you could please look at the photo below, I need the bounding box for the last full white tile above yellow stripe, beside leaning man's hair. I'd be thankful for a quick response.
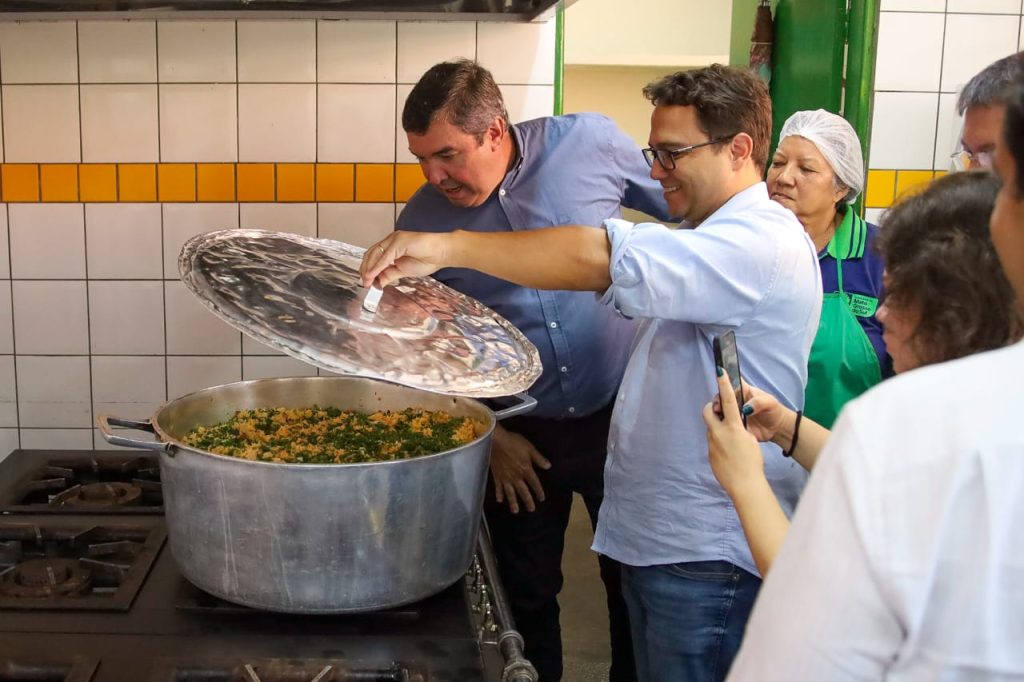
[316,84,400,163]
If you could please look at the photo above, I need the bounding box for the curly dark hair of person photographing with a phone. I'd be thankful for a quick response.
[877,171,1024,365]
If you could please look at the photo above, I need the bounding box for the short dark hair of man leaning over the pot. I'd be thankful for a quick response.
[401,59,509,142]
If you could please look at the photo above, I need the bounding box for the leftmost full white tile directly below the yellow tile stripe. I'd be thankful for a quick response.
[8,204,85,280]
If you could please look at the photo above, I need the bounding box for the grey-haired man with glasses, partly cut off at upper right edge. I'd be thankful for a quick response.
[951,52,1024,171]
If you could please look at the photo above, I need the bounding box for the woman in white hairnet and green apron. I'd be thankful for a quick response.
[768,109,892,428]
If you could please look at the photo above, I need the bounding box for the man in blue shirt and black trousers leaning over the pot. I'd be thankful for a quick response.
[397,60,669,682]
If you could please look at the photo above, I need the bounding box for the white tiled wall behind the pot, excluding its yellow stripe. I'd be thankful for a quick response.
[0,17,554,450]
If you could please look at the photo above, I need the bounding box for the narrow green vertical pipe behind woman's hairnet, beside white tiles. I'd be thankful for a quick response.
[844,0,879,211]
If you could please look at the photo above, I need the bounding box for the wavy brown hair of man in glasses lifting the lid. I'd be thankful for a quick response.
[643,63,771,173]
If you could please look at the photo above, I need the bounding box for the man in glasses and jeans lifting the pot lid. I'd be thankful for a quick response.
[362,65,821,681]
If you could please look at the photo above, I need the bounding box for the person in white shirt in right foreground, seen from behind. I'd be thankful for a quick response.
[729,71,1024,682]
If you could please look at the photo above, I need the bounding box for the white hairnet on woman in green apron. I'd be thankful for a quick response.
[778,109,864,204]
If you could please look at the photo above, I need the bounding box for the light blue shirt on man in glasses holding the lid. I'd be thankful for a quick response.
[594,182,821,574]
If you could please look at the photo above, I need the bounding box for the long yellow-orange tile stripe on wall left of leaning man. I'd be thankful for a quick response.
[0,163,424,203]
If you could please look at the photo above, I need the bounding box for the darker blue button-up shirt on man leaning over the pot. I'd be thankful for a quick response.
[397,114,669,418]
